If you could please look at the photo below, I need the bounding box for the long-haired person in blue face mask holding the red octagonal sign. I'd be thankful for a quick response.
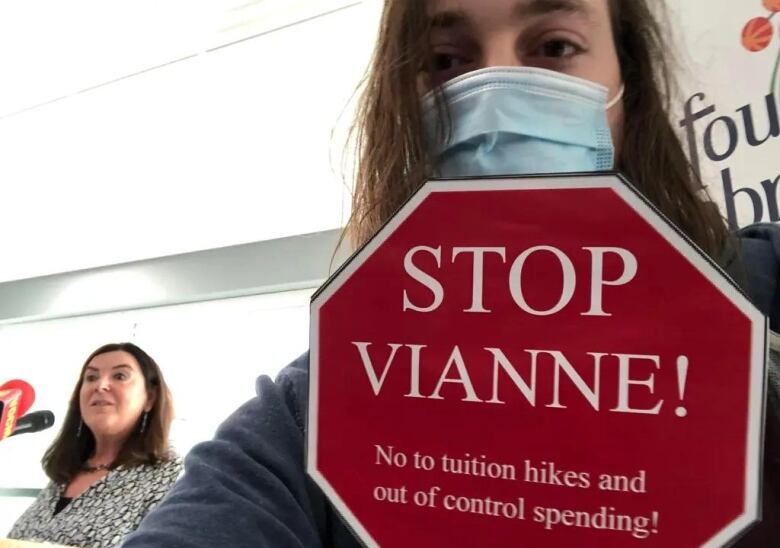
[126,0,780,548]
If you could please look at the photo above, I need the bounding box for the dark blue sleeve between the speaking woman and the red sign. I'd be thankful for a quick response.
[123,356,327,548]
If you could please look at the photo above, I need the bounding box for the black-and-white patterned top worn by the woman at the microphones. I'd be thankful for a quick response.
[8,458,182,548]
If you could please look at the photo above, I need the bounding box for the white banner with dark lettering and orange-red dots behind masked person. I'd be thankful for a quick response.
[668,0,780,227]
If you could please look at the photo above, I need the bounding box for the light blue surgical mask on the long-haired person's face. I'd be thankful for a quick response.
[423,67,623,177]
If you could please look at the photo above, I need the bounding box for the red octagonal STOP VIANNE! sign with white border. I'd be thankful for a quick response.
[307,174,766,547]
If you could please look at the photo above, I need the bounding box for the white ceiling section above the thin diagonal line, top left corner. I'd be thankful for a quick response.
[0,0,361,120]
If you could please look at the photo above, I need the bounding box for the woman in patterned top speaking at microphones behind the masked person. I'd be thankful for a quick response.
[9,343,181,548]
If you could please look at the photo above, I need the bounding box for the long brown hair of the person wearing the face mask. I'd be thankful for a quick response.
[347,0,728,259]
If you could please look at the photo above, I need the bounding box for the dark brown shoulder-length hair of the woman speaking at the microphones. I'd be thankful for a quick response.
[42,342,173,484]
